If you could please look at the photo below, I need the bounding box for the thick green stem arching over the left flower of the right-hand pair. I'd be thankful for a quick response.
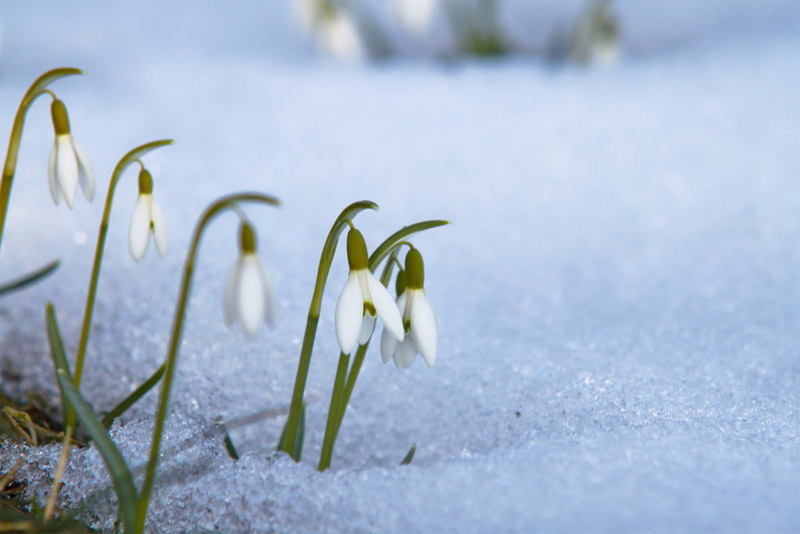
[281,200,378,460]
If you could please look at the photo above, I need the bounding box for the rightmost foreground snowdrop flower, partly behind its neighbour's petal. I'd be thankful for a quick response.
[381,248,438,367]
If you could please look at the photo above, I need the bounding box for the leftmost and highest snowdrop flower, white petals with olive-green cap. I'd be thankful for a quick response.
[48,98,94,209]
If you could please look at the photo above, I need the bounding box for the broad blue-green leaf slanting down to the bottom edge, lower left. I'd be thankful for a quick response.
[57,369,139,532]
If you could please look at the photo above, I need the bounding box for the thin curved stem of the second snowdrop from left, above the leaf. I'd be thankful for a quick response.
[71,139,174,396]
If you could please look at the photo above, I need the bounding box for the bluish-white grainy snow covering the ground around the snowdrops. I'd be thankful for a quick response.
[0,0,800,532]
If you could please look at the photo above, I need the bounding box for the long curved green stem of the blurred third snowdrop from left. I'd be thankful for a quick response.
[136,193,280,532]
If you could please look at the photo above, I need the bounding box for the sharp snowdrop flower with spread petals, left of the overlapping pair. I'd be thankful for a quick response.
[334,228,403,354]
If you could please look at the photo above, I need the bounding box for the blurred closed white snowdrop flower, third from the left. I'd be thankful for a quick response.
[223,222,278,337]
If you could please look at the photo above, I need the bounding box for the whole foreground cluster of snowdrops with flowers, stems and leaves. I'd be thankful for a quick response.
[0,68,447,532]
